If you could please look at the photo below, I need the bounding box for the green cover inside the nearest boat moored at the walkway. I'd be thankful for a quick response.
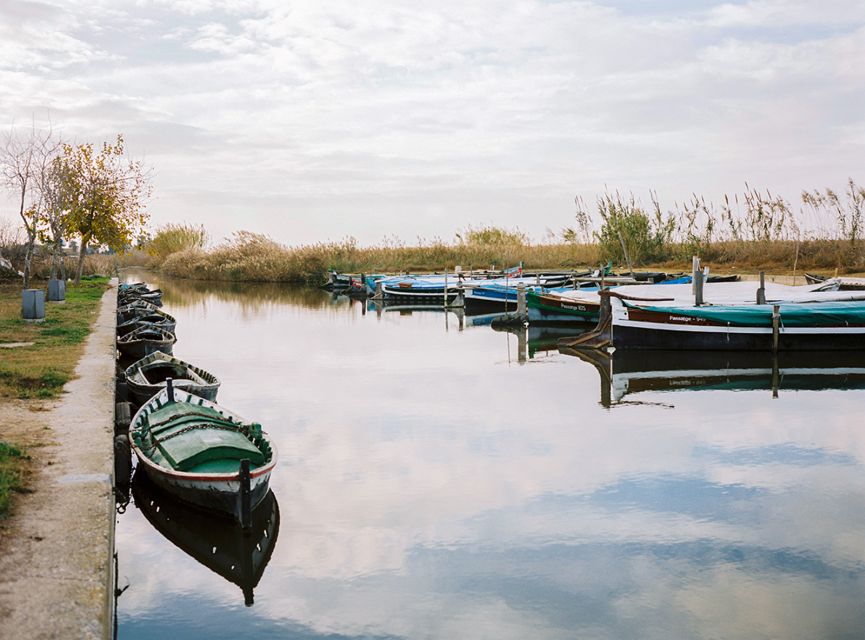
[148,402,266,471]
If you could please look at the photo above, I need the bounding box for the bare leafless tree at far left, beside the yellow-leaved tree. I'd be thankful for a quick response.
[0,122,58,289]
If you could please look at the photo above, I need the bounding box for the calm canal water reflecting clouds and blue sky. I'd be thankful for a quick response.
[117,276,865,640]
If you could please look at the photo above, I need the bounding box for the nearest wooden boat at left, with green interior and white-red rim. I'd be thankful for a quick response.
[129,384,277,522]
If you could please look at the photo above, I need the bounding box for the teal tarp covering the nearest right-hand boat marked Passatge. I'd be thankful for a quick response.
[624,301,865,327]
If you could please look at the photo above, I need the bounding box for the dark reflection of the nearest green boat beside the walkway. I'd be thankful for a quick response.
[132,473,279,606]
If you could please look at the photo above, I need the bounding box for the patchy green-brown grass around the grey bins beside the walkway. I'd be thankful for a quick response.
[0,278,108,398]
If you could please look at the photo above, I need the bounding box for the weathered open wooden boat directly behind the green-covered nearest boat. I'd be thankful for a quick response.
[125,351,219,404]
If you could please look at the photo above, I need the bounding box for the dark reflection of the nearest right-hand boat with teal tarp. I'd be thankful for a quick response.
[560,347,865,402]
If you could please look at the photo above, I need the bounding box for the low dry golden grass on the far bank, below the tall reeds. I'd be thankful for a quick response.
[154,234,862,284]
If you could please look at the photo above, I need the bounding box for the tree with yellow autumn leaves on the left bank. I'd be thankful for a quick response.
[58,135,151,282]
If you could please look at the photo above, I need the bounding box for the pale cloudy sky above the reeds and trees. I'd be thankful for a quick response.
[0,0,865,245]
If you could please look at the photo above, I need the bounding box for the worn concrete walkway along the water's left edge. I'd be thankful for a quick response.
[0,280,117,640]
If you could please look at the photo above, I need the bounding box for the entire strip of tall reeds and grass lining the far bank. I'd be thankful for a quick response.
[145,179,865,284]
